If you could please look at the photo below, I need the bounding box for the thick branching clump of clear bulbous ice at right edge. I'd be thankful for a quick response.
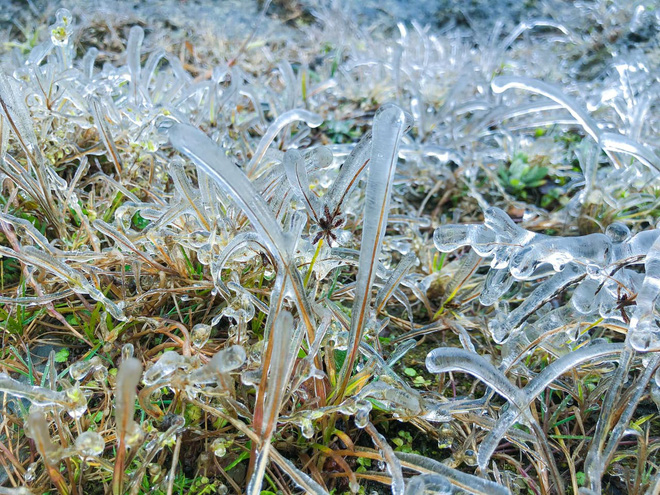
[433,207,660,340]
